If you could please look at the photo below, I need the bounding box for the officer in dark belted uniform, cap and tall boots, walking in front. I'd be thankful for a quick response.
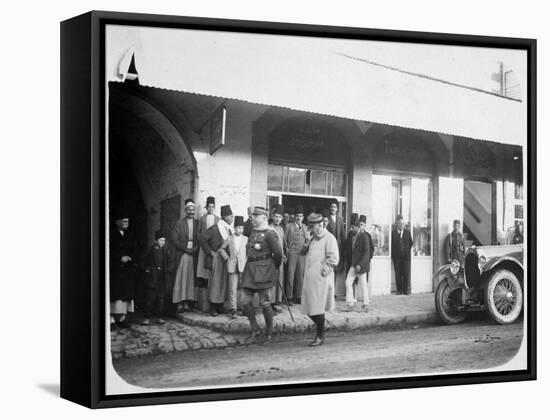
[241,207,283,344]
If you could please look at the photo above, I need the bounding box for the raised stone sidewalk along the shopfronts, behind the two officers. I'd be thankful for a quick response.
[111,293,438,360]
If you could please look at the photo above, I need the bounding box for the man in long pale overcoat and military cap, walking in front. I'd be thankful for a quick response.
[302,213,340,346]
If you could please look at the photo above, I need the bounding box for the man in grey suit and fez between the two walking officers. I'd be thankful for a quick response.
[285,205,309,304]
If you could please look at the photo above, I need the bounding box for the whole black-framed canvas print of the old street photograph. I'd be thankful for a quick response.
[61,11,537,408]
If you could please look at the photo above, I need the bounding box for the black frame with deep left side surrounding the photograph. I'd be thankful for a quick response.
[60,11,537,408]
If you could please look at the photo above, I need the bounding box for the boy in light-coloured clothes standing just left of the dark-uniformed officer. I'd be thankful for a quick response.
[227,216,248,319]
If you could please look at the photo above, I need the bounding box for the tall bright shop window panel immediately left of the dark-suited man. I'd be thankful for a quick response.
[371,175,392,256]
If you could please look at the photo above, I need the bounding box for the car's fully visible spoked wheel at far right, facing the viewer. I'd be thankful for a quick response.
[485,269,523,324]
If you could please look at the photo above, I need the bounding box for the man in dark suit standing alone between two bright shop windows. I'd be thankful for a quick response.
[391,215,412,295]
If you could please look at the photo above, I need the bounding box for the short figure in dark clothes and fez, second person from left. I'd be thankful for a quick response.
[141,230,174,325]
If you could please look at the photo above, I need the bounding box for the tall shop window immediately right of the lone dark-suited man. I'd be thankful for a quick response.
[411,178,432,256]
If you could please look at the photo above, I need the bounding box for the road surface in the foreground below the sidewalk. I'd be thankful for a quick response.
[115,320,523,388]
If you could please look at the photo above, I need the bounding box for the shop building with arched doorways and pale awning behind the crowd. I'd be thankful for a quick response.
[106,26,527,295]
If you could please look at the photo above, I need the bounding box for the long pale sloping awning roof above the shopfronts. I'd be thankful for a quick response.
[106,25,527,145]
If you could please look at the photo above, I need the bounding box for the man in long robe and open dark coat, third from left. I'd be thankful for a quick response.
[172,198,199,312]
